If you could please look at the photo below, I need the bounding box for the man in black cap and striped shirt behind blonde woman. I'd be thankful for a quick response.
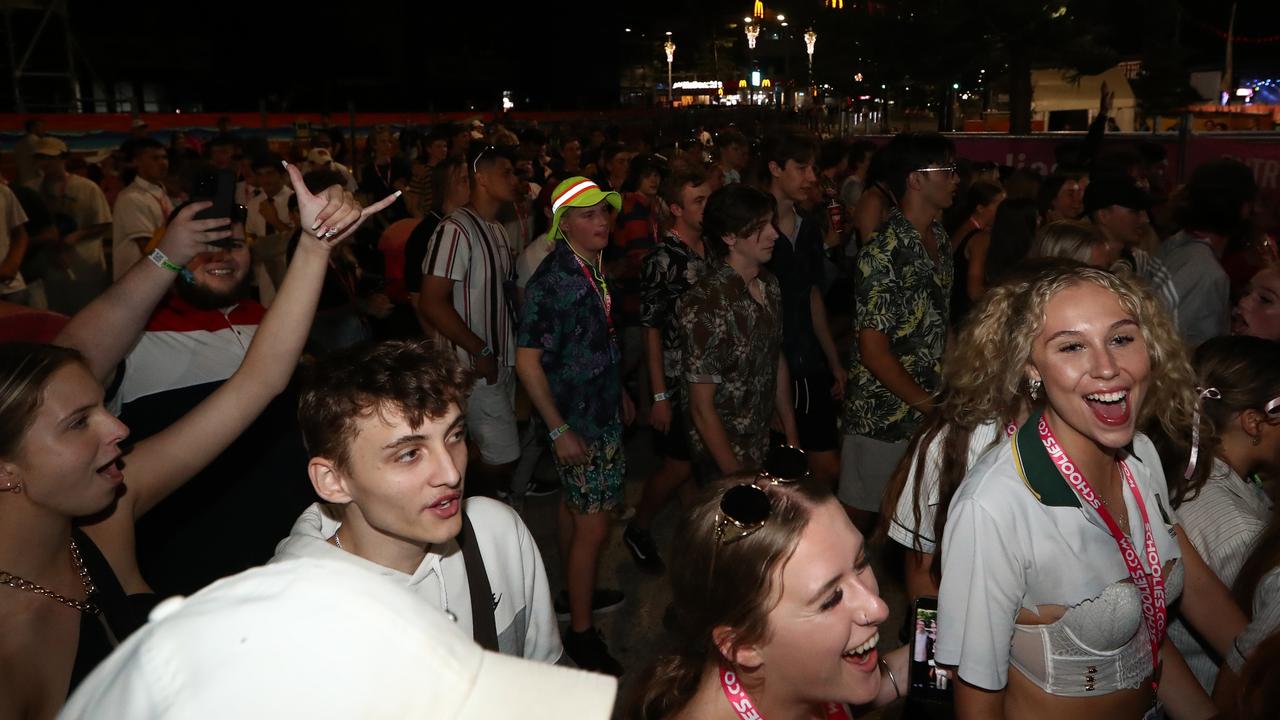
[1084,177,1180,322]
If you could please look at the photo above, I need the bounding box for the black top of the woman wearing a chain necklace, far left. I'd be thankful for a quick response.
[68,528,159,694]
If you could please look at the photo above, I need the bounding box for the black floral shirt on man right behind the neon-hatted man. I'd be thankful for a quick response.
[640,234,707,392]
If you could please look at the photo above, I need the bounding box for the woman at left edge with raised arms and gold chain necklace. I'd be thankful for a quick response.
[0,167,394,717]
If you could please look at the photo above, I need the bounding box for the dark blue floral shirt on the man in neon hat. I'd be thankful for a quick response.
[516,241,622,445]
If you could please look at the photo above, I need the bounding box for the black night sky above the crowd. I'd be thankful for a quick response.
[12,0,1280,111]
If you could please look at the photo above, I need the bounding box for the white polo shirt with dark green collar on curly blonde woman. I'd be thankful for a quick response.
[936,415,1181,691]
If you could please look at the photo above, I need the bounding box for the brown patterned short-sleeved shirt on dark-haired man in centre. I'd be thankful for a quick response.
[678,261,782,465]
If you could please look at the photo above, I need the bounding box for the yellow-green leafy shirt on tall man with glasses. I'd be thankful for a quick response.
[844,208,955,442]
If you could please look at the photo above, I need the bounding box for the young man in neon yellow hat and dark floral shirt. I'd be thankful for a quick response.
[516,176,635,675]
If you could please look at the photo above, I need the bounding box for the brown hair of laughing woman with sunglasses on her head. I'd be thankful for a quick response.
[632,473,835,720]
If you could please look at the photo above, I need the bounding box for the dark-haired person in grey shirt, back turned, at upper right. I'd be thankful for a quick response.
[1156,159,1258,346]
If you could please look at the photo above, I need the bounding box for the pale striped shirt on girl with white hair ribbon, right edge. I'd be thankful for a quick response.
[1169,459,1271,692]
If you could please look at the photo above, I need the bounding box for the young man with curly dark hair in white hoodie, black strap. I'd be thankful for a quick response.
[271,341,561,662]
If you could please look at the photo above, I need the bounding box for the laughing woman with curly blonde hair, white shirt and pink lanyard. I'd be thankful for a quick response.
[937,266,1211,720]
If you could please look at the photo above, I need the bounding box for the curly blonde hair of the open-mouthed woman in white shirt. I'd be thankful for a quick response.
[943,264,1196,433]
